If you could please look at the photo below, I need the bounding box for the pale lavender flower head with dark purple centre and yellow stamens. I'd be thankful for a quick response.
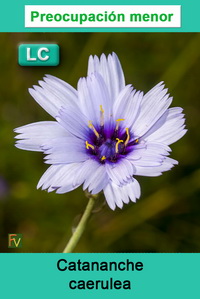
[15,53,186,210]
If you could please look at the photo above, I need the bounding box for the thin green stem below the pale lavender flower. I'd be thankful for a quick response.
[63,193,97,253]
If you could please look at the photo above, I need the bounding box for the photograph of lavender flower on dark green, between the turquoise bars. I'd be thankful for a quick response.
[0,33,200,252]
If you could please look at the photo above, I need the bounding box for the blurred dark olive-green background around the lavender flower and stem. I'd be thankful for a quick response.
[0,33,200,252]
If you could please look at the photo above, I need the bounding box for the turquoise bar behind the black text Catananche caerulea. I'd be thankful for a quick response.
[0,253,200,299]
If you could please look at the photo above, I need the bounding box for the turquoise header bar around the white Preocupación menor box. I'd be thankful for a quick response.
[0,0,200,32]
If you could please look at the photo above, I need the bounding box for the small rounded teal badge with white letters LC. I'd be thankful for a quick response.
[18,44,60,66]
